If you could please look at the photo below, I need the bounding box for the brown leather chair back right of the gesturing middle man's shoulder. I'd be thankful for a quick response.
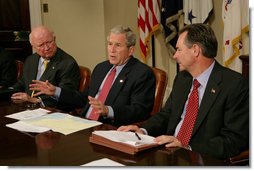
[151,67,168,115]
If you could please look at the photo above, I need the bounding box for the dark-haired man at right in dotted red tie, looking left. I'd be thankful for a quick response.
[118,24,249,159]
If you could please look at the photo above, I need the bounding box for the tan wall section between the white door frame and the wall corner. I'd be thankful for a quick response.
[41,0,106,69]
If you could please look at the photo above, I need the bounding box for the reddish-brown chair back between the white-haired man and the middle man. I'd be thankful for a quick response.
[79,66,91,92]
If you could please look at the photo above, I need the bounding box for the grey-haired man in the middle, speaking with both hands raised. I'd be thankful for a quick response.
[30,26,155,126]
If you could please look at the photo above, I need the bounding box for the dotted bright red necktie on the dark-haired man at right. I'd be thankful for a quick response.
[177,79,200,145]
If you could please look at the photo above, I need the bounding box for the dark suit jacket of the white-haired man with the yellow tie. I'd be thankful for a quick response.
[13,48,80,110]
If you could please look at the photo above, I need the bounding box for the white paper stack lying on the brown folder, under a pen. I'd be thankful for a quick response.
[93,130,155,146]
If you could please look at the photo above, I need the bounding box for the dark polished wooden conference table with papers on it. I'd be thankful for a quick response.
[0,100,227,166]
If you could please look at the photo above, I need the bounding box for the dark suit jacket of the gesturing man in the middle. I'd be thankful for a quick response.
[59,57,155,126]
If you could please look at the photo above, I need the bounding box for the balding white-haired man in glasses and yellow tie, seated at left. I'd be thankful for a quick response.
[11,26,80,111]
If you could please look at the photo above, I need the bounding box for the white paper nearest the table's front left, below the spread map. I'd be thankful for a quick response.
[6,121,50,133]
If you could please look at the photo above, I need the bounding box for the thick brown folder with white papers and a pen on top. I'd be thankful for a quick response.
[89,130,159,154]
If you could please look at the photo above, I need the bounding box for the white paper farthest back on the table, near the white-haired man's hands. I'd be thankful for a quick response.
[5,108,50,120]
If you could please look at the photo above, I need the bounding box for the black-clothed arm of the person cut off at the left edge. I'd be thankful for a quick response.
[0,47,17,87]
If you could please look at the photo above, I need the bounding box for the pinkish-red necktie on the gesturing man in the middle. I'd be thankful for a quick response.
[89,67,116,120]
